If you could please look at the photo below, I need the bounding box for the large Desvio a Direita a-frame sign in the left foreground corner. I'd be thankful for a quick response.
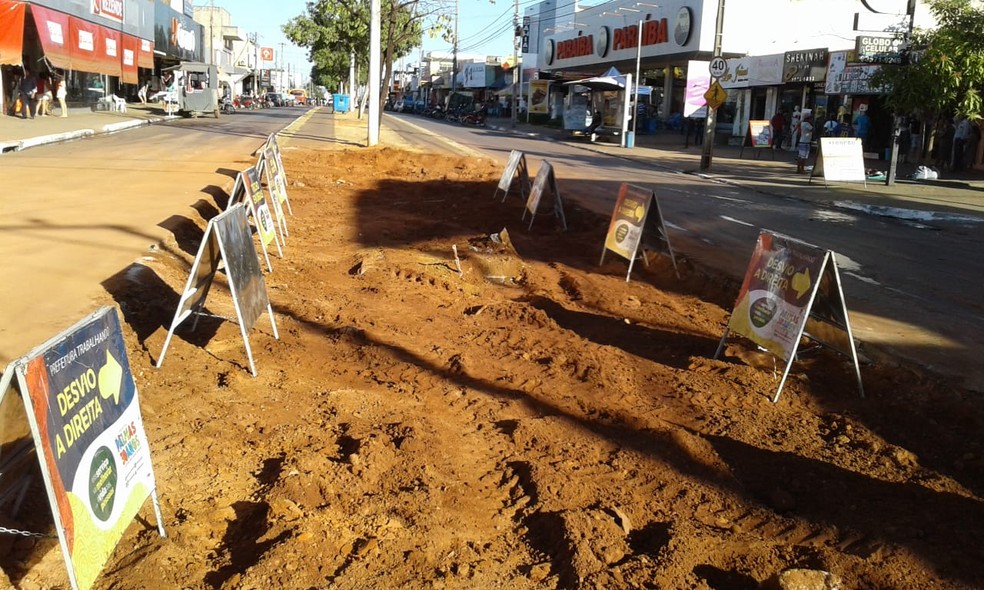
[0,307,165,590]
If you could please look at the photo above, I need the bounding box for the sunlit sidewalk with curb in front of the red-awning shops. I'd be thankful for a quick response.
[0,103,164,154]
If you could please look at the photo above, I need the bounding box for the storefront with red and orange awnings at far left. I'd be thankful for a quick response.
[0,0,153,112]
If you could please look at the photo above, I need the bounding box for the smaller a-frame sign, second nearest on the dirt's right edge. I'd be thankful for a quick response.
[598,182,680,283]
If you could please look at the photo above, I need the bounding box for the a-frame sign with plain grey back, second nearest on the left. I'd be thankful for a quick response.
[157,205,280,377]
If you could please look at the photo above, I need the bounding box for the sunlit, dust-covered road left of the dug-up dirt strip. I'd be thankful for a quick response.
[0,108,304,366]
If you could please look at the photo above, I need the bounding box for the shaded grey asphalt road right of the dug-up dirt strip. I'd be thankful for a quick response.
[386,114,984,391]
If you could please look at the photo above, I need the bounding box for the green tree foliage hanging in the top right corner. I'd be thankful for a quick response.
[872,0,984,120]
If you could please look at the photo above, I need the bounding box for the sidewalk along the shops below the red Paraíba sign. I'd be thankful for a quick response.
[488,119,984,223]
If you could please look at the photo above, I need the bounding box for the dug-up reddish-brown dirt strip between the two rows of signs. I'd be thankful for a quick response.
[0,117,984,590]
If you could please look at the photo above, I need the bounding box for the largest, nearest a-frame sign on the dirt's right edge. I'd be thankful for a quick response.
[714,230,864,402]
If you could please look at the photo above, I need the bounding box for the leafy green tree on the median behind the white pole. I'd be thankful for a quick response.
[282,0,448,119]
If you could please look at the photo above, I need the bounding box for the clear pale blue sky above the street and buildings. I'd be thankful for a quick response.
[203,0,539,80]
